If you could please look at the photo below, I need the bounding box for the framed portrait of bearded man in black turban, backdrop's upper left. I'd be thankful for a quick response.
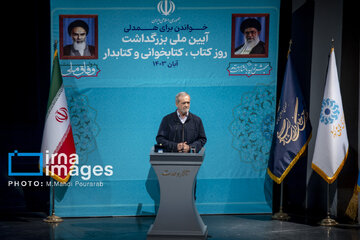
[59,15,98,59]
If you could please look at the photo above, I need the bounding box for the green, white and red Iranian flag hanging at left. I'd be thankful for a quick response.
[41,45,77,183]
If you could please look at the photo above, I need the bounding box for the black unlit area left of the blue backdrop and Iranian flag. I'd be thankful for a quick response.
[0,0,51,214]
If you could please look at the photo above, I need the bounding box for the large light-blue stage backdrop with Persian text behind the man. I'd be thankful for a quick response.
[51,0,280,217]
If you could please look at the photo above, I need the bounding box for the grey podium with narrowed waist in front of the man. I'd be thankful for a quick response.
[147,148,207,240]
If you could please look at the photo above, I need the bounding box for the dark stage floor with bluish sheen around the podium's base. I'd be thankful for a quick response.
[0,214,360,240]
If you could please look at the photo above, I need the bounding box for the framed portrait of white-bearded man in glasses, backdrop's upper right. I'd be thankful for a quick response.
[231,13,269,58]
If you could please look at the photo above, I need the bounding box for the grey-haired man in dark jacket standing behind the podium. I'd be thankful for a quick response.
[156,92,206,152]
